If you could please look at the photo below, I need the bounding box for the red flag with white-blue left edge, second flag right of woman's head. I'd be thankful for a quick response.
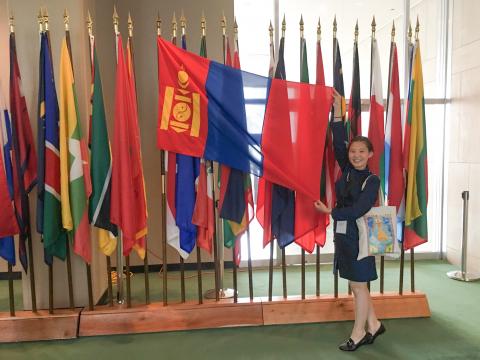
[385,41,405,233]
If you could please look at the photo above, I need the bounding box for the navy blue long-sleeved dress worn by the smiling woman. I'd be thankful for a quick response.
[332,122,380,282]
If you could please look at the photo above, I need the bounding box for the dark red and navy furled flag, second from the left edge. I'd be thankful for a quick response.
[10,32,37,271]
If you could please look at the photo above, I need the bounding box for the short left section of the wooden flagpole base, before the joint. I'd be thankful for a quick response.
[0,309,81,343]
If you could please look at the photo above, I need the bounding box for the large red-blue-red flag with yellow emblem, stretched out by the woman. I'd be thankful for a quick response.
[157,38,332,204]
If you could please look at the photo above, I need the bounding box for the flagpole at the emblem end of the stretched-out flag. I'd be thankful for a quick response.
[156,12,168,306]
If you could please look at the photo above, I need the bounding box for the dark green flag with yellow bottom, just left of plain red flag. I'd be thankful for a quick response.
[88,36,118,256]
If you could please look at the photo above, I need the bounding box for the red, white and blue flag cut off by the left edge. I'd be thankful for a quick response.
[0,94,20,266]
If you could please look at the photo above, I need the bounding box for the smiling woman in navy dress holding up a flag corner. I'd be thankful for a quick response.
[314,91,385,351]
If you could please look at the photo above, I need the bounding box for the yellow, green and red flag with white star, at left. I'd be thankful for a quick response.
[59,38,92,263]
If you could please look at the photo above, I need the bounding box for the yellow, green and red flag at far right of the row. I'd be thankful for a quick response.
[404,40,428,250]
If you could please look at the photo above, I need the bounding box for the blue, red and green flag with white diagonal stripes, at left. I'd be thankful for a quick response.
[37,33,68,265]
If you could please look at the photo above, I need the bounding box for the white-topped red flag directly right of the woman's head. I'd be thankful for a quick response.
[368,39,385,193]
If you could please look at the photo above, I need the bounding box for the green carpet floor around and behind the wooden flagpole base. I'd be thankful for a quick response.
[0,261,480,360]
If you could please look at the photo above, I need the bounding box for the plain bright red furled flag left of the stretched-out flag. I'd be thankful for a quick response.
[110,35,147,255]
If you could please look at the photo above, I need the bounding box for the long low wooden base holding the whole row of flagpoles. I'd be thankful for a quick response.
[0,292,430,342]
